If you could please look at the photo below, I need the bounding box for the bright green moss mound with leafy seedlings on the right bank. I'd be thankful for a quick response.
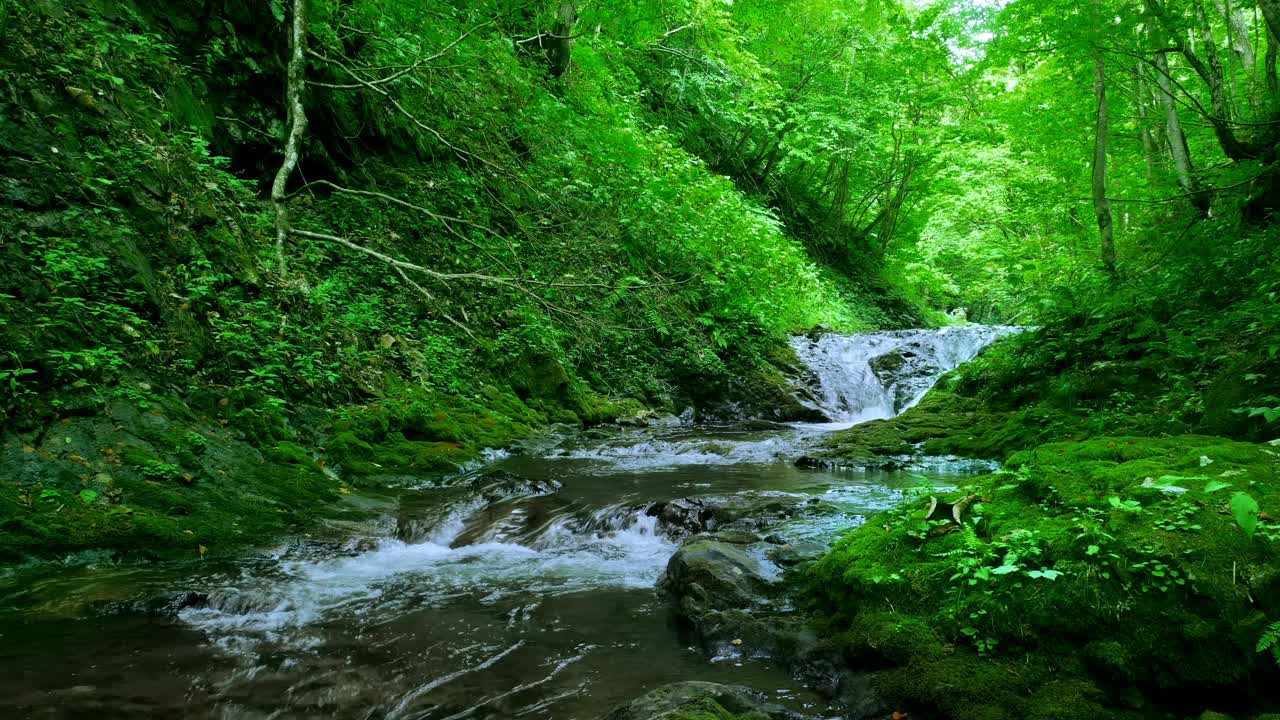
[808,436,1280,717]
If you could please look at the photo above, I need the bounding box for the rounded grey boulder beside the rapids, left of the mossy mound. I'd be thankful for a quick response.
[660,538,771,616]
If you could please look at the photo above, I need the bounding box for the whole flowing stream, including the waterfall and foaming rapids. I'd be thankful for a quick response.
[0,328,1009,720]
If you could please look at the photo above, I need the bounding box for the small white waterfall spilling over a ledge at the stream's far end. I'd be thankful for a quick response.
[791,325,1023,424]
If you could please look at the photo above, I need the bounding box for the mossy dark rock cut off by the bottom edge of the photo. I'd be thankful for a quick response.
[604,682,804,720]
